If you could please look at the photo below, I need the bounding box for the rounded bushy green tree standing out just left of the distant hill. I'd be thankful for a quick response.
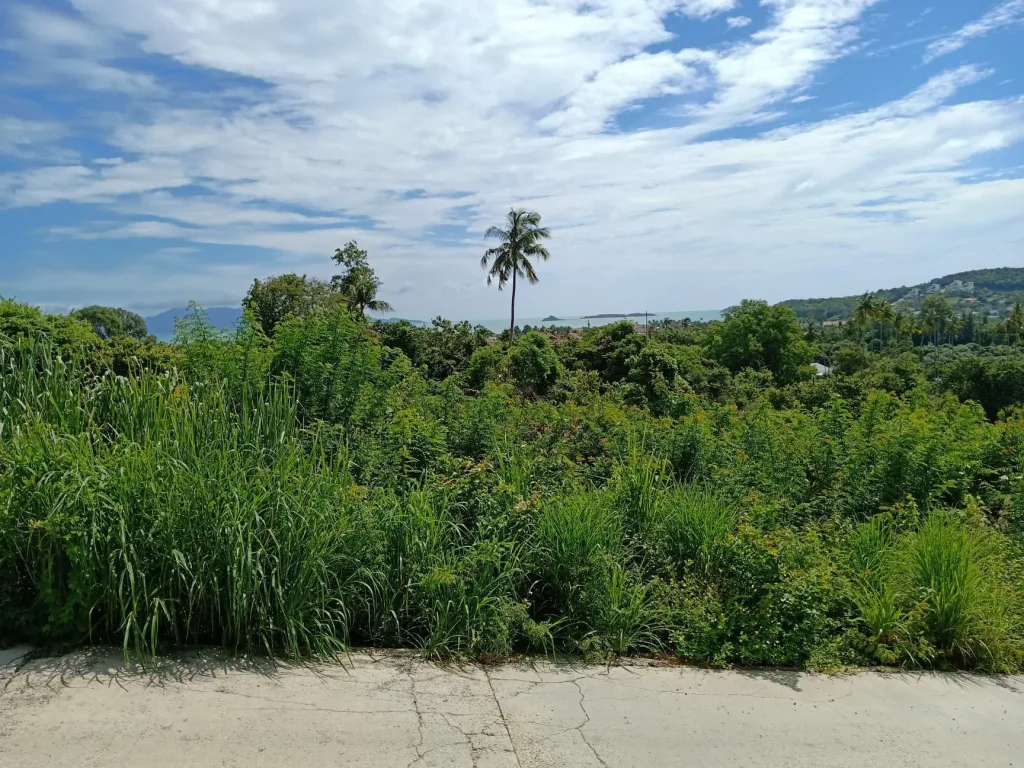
[708,300,814,384]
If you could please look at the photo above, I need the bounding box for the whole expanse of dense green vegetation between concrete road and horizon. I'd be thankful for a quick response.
[6,256,1024,670]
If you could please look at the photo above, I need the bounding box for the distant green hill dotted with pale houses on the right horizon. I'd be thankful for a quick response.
[781,266,1024,321]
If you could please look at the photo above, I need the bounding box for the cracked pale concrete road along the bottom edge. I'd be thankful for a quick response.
[0,650,1024,768]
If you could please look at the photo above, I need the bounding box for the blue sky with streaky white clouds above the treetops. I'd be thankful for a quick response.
[0,0,1024,319]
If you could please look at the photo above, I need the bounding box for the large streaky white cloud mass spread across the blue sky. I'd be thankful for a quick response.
[0,0,1024,317]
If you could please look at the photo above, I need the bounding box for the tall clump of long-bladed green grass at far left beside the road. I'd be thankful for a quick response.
[0,353,360,654]
